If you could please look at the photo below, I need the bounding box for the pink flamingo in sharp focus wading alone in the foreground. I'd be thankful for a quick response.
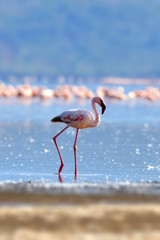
[51,97,106,177]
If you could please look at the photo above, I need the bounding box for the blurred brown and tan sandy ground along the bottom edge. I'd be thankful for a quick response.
[0,192,160,240]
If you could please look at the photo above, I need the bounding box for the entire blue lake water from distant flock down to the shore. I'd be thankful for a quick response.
[0,96,160,183]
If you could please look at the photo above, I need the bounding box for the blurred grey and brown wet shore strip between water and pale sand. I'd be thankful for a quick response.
[0,182,160,205]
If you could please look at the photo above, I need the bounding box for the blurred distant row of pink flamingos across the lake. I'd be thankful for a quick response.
[0,82,160,101]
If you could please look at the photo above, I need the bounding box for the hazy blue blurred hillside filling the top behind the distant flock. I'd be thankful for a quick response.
[0,0,160,78]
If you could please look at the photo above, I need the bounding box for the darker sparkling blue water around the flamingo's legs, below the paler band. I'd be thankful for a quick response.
[0,116,160,183]
